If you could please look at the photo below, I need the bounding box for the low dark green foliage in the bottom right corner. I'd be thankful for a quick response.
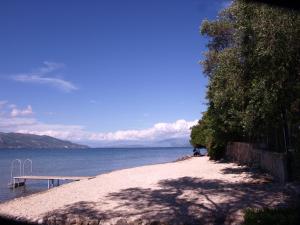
[243,208,300,225]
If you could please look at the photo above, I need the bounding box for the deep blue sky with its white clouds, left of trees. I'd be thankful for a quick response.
[0,0,228,146]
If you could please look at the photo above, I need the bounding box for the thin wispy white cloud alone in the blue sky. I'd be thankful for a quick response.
[11,61,78,92]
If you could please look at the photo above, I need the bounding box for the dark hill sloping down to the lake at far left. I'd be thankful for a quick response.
[0,132,89,149]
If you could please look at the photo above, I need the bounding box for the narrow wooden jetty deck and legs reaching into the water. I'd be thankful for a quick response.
[10,176,94,189]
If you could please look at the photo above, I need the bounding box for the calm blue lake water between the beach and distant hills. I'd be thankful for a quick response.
[0,148,192,202]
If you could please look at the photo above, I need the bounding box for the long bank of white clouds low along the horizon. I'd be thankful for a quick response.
[0,101,197,146]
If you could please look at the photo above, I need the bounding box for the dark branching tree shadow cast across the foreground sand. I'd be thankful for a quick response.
[43,165,291,224]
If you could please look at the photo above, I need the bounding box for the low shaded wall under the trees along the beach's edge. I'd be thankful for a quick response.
[226,142,288,183]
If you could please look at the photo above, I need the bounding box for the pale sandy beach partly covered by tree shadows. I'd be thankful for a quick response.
[0,157,289,224]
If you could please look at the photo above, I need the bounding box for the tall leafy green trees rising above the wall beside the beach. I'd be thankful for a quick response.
[191,0,300,158]
